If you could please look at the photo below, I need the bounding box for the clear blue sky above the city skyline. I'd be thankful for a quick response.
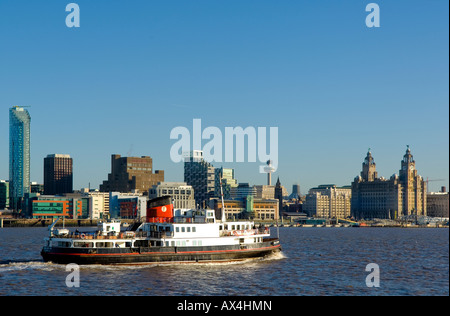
[0,0,449,194]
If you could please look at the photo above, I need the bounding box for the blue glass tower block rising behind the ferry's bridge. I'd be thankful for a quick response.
[184,150,215,207]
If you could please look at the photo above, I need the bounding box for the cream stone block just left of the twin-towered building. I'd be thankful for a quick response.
[302,184,352,218]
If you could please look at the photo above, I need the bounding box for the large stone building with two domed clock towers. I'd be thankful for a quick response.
[351,146,427,219]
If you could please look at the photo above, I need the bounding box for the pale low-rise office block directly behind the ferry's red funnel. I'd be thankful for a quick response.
[148,182,195,209]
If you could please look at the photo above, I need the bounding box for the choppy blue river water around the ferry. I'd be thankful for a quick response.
[0,227,449,296]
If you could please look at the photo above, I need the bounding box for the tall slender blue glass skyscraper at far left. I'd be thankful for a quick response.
[9,106,31,209]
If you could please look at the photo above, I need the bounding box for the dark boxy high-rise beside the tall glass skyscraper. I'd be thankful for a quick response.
[44,154,73,195]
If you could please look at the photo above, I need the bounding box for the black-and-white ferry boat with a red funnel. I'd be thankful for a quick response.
[41,196,281,264]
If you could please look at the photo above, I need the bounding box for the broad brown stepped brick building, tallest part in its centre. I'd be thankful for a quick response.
[100,155,164,193]
